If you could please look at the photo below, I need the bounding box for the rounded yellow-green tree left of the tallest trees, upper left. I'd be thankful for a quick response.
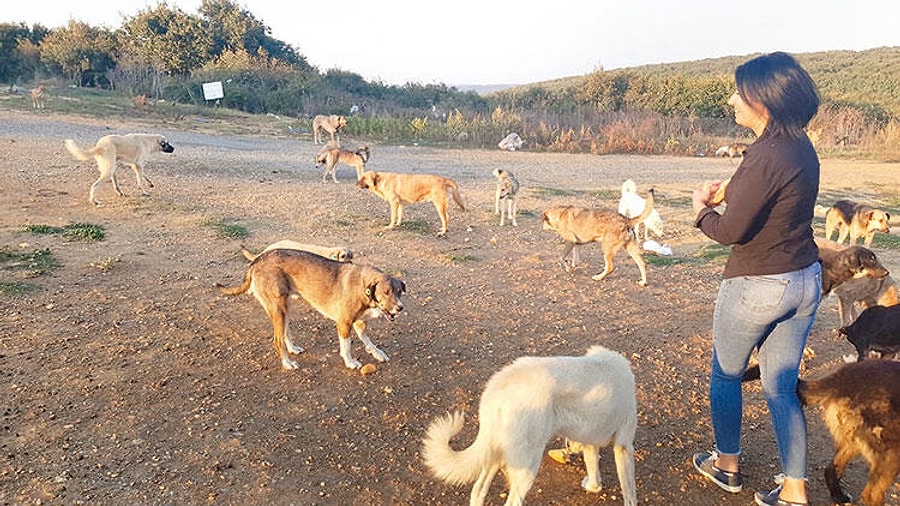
[38,19,116,86]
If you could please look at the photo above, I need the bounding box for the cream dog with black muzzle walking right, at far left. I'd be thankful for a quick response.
[65,134,175,206]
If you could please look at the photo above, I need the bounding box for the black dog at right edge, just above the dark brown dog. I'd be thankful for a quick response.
[839,305,900,362]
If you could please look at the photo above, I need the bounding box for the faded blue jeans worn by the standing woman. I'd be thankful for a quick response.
[709,262,822,479]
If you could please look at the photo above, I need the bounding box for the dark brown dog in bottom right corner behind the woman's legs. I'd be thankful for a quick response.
[797,360,900,506]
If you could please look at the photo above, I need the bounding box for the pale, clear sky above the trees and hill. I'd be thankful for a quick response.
[7,0,900,86]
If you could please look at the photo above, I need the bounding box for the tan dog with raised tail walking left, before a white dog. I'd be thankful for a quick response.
[543,190,654,286]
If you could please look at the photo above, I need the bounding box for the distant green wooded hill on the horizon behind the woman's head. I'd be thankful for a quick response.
[505,46,900,117]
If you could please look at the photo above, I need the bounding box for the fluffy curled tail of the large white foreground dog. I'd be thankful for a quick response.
[422,411,491,485]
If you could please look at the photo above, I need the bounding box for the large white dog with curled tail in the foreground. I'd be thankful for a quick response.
[422,346,637,506]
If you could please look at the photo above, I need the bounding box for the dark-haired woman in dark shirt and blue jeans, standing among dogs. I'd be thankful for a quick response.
[692,52,821,505]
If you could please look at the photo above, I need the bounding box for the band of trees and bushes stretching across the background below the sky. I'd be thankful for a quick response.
[0,0,900,154]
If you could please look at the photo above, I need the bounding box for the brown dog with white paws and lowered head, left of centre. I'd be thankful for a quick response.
[216,249,406,369]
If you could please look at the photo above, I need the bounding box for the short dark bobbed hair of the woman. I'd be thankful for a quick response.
[734,52,819,137]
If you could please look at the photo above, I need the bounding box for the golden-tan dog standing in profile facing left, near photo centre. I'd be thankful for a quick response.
[356,171,466,236]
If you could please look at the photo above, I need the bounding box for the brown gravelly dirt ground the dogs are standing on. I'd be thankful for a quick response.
[0,112,900,506]
